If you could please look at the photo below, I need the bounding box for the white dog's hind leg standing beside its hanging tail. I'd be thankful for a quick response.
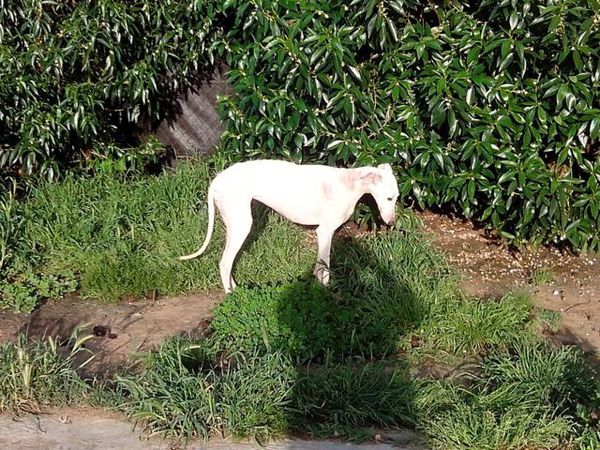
[217,199,252,293]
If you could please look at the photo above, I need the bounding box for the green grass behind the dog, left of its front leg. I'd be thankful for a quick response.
[0,164,315,311]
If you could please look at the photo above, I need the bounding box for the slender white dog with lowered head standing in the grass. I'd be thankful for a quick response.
[179,160,398,293]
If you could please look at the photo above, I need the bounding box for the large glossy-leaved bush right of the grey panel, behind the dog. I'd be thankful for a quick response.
[221,0,600,249]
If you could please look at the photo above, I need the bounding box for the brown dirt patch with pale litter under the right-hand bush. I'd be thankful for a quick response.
[419,212,600,360]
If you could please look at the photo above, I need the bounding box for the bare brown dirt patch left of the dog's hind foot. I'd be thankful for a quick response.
[0,292,223,374]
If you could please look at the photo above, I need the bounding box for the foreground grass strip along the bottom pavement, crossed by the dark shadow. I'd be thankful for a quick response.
[113,328,600,449]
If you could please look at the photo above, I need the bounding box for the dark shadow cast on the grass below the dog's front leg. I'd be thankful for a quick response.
[264,234,427,446]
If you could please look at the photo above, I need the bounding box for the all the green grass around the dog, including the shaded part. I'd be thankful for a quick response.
[0,158,600,450]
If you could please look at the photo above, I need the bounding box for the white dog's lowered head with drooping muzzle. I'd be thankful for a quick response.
[360,163,399,225]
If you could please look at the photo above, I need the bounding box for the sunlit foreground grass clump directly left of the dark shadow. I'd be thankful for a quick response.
[118,339,294,439]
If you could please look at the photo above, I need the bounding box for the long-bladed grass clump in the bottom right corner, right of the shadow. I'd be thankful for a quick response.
[415,340,596,449]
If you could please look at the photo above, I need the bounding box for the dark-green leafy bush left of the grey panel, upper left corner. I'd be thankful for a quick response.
[0,0,221,178]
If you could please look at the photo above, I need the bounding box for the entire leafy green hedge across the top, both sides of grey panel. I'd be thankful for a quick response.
[5,0,600,250]
